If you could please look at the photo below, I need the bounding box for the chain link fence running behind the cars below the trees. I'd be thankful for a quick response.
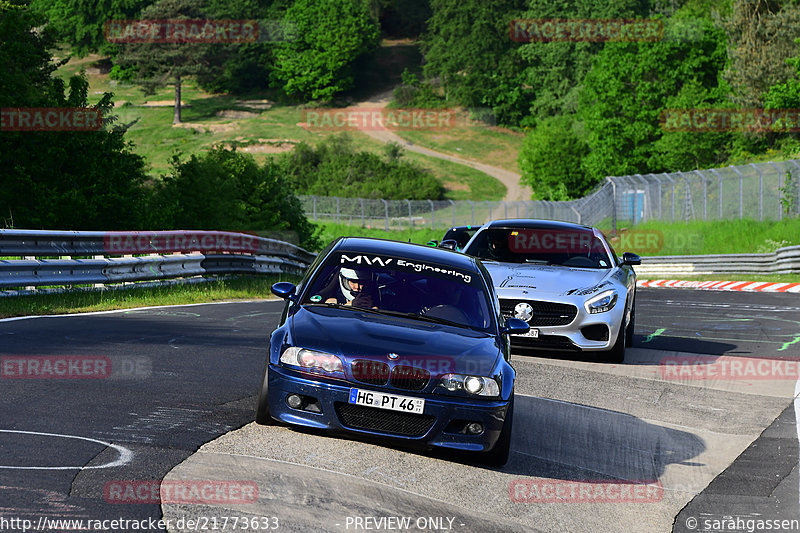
[299,160,800,230]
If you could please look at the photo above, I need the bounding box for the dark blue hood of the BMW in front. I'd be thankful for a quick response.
[290,306,502,375]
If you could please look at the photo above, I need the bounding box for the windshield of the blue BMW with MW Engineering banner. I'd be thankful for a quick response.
[301,252,494,332]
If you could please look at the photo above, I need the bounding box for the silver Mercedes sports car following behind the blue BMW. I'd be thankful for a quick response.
[440,220,641,362]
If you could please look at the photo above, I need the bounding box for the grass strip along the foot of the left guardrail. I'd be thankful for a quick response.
[0,276,298,318]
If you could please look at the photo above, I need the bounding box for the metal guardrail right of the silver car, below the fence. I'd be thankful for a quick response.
[635,246,800,277]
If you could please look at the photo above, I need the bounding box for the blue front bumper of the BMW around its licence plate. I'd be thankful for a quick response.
[268,364,509,452]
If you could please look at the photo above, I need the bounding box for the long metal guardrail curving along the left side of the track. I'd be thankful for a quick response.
[0,230,315,288]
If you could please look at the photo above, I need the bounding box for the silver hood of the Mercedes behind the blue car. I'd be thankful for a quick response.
[483,261,614,296]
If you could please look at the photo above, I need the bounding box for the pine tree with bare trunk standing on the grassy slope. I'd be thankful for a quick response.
[116,0,215,124]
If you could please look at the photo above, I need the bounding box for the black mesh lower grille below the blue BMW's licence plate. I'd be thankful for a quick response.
[334,403,436,437]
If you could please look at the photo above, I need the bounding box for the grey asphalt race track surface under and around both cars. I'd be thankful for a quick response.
[0,289,800,531]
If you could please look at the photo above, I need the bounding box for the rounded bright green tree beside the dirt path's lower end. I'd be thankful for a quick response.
[519,115,593,200]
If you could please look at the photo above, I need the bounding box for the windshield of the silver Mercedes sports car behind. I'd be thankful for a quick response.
[465,228,613,268]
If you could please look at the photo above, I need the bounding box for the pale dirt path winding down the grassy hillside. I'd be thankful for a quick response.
[353,90,531,202]
